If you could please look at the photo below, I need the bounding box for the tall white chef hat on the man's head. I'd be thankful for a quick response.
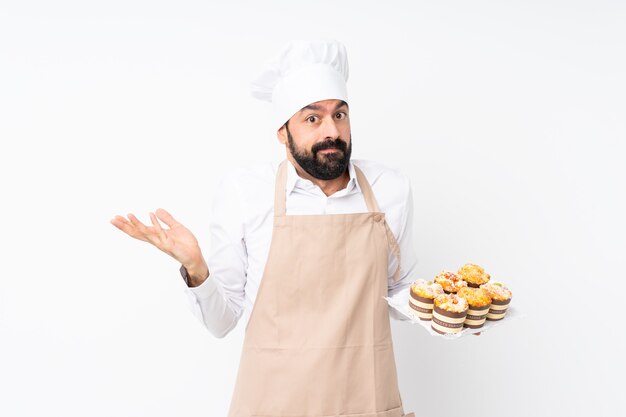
[252,40,348,129]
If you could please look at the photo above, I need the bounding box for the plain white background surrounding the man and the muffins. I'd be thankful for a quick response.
[0,0,626,417]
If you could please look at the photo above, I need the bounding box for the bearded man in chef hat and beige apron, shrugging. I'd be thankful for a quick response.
[112,41,416,417]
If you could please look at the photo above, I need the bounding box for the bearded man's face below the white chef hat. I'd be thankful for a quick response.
[278,100,352,180]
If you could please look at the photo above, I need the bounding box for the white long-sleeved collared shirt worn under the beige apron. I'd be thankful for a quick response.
[185,160,417,337]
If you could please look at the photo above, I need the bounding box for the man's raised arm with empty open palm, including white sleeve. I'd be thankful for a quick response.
[111,172,247,337]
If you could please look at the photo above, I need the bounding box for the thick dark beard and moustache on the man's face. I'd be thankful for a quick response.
[287,127,352,180]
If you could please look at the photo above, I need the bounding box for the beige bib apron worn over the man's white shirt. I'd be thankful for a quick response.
[228,160,414,417]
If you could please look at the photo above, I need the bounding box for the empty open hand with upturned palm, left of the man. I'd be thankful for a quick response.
[111,208,208,270]
